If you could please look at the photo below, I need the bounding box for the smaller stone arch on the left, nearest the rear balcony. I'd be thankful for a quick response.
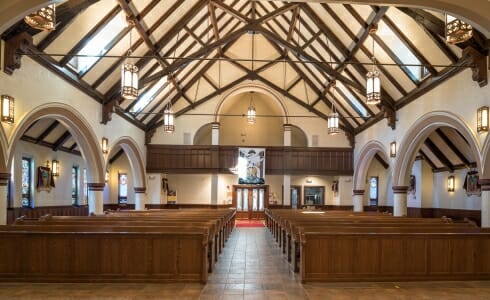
[106,136,146,188]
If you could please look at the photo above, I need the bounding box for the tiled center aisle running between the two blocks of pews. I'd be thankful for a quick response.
[200,227,308,300]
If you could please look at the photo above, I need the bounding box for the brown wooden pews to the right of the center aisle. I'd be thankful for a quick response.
[265,209,490,282]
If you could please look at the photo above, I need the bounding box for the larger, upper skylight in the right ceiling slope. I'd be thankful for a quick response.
[377,22,422,81]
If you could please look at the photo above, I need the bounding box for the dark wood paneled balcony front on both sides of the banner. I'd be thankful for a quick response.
[146,145,354,176]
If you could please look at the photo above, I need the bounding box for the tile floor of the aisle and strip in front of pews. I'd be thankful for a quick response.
[0,228,490,300]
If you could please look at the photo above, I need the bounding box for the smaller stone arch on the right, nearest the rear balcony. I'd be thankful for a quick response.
[353,141,390,190]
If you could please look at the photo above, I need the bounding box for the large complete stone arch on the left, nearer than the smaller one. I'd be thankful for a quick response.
[7,102,105,183]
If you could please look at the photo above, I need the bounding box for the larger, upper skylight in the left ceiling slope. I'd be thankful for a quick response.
[68,15,127,74]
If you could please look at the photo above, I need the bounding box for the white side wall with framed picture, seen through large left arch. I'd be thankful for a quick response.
[12,141,85,207]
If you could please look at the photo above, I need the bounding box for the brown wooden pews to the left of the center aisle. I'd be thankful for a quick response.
[0,209,235,283]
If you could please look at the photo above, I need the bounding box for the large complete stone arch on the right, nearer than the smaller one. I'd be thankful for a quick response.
[393,111,482,187]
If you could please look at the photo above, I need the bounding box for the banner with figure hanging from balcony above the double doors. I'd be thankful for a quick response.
[238,148,265,184]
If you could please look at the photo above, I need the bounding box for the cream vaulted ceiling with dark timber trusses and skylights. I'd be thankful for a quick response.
[2,0,488,169]
